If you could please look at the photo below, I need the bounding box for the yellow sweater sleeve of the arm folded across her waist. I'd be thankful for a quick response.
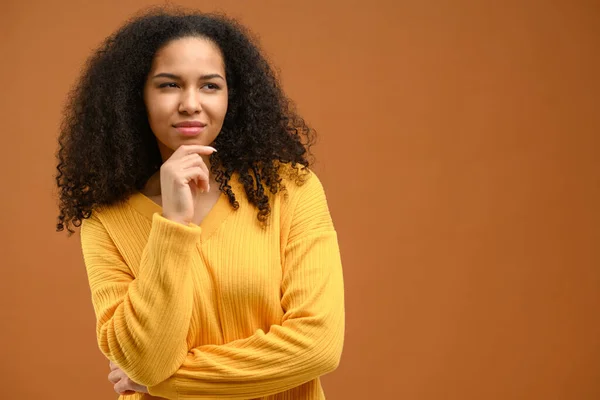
[148,174,344,399]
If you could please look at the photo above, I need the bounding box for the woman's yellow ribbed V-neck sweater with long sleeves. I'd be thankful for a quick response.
[81,173,344,400]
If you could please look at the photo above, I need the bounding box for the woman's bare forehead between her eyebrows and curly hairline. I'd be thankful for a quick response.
[152,37,225,74]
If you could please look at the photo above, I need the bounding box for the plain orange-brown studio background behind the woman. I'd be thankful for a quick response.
[0,0,600,400]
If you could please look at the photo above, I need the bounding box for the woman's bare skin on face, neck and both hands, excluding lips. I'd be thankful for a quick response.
[108,37,228,394]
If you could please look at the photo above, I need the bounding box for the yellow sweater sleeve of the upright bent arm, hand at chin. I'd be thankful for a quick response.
[81,214,200,386]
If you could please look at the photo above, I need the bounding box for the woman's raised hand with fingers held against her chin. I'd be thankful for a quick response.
[160,145,216,225]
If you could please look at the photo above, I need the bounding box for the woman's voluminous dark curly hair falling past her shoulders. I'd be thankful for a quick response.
[56,7,315,234]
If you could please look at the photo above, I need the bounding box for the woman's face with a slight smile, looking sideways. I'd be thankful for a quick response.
[144,37,227,161]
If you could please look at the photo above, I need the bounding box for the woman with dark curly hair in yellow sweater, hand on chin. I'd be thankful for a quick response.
[56,9,344,399]
